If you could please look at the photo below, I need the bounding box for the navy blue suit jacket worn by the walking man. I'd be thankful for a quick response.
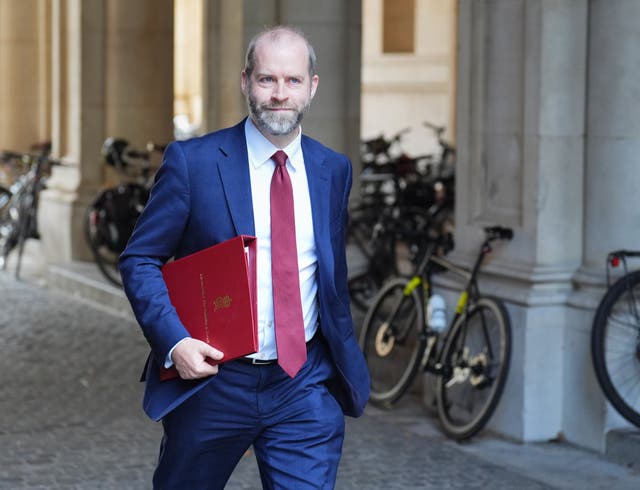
[119,121,369,420]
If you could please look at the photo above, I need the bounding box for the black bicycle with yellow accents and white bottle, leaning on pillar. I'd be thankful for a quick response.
[359,226,513,440]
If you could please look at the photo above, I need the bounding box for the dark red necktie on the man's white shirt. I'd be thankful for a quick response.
[271,150,307,378]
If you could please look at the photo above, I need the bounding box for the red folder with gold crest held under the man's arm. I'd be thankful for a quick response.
[160,235,258,381]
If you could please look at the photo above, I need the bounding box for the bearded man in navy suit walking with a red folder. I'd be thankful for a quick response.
[120,27,369,489]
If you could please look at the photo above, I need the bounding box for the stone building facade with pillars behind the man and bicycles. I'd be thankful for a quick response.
[0,0,640,451]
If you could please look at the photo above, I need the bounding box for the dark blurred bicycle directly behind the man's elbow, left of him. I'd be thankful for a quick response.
[84,138,165,287]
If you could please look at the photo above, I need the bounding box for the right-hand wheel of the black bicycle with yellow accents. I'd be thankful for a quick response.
[436,298,511,440]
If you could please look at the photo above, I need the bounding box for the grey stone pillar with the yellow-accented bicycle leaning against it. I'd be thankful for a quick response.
[452,0,587,441]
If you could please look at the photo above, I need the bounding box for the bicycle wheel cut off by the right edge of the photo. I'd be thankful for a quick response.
[591,271,640,427]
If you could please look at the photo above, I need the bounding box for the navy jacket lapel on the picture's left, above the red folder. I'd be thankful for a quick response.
[218,120,255,235]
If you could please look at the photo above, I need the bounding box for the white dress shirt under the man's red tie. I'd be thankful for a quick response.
[244,118,318,359]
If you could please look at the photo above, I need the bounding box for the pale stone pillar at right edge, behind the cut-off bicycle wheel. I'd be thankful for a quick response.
[566,0,640,450]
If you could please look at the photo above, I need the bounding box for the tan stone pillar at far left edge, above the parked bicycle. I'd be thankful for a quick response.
[0,0,51,151]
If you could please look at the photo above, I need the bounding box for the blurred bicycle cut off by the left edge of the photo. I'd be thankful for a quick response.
[0,143,61,279]
